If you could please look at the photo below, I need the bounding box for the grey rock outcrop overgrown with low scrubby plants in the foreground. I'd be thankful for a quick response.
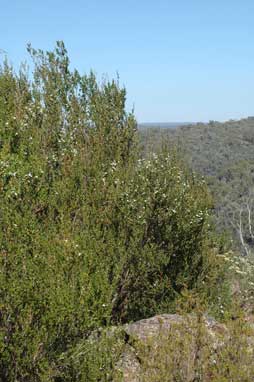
[85,314,254,382]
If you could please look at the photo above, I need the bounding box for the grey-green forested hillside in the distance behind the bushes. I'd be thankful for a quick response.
[140,117,254,255]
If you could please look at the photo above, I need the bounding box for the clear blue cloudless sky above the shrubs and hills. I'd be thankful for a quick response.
[0,0,254,122]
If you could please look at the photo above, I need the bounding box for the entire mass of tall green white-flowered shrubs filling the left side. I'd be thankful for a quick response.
[0,42,228,382]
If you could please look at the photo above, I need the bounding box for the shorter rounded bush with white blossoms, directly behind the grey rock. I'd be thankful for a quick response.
[113,153,228,322]
